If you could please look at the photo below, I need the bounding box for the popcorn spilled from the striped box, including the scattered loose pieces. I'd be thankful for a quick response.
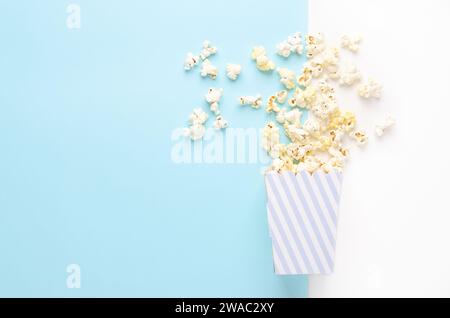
[179,32,395,174]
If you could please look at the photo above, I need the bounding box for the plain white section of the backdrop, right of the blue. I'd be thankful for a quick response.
[309,0,450,297]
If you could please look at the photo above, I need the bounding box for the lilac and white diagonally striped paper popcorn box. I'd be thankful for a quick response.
[265,171,342,275]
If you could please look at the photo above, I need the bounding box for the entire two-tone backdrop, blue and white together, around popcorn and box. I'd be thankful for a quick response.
[0,0,450,297]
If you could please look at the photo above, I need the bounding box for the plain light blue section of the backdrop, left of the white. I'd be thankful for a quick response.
[0,0,307,297]
